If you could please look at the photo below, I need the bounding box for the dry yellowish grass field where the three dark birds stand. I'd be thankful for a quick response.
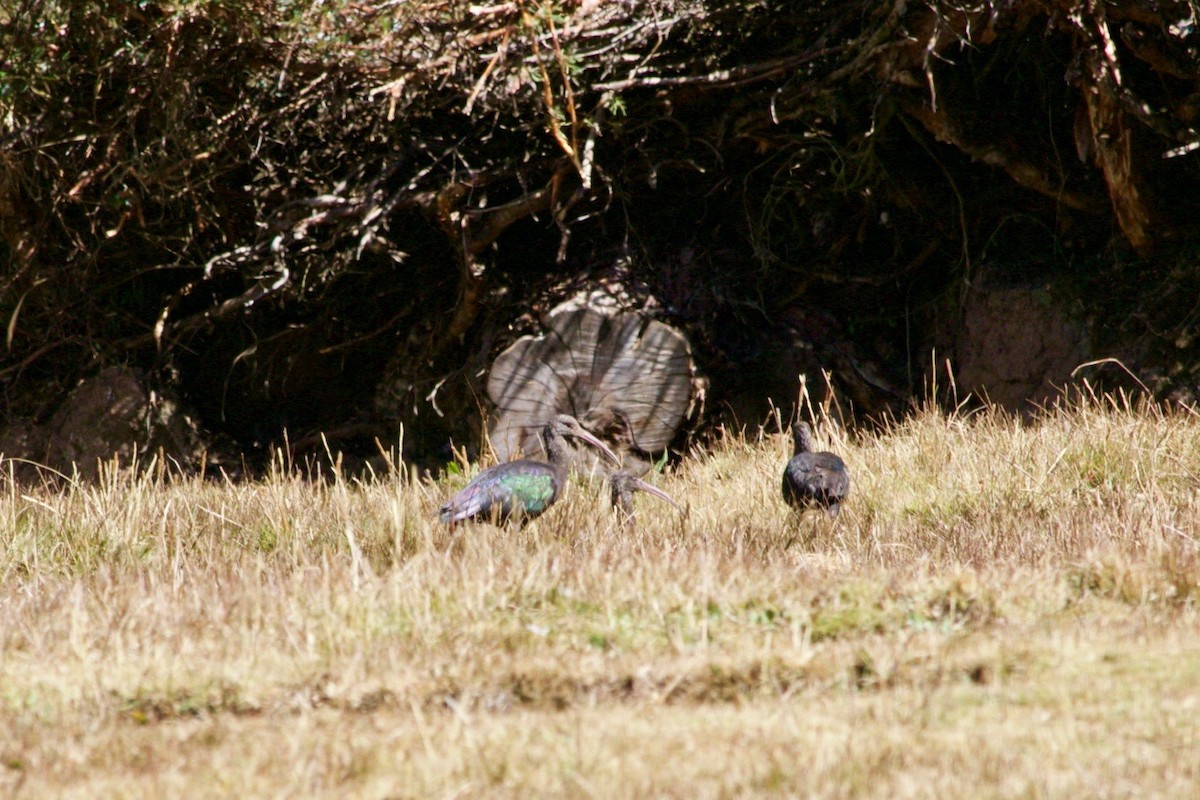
[0,402,1200,798]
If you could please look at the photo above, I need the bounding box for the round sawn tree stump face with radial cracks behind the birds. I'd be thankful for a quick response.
[487,302,692,474]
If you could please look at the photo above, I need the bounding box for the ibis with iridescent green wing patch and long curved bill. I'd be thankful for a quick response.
[440,414,620,525]
